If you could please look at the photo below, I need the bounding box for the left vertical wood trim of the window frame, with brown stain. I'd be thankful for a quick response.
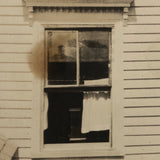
[32,22,44,154]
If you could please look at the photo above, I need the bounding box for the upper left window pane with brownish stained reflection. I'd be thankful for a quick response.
[47,31,76,85]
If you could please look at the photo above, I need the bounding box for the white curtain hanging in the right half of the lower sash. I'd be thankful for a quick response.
[81,91,111,133]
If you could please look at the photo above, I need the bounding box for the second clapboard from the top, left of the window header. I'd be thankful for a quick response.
[0,6,25,16]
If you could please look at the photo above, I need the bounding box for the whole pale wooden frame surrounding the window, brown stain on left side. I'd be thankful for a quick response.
[31,16,124,158]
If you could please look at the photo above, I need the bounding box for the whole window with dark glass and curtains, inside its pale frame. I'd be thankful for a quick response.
[44,28,112,144]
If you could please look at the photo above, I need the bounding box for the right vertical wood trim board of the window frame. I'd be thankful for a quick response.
[111,22,123,151]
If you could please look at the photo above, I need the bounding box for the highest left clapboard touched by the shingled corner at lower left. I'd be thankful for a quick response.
[0,127,31,138]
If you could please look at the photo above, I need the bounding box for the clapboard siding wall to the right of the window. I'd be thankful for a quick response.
[124,0,160,160]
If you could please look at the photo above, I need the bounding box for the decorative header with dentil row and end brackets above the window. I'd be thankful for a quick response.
[24,0,134,25]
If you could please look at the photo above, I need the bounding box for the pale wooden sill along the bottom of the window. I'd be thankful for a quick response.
[32,143,124,158]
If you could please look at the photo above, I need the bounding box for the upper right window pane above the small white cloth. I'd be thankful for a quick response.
[79,31,109,84]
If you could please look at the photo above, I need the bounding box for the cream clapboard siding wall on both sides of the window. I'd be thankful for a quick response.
[0,0,160,160]
